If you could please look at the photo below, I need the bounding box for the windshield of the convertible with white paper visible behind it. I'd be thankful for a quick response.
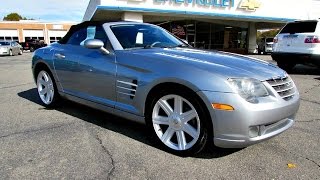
[111,24,188,49]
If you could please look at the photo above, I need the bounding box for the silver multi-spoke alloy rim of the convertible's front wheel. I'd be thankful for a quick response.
[152,95,200,151]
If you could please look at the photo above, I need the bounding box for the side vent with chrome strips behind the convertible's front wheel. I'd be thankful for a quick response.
[117,80,138,99]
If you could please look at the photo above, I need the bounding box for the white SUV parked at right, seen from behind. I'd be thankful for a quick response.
[272,20,320,71]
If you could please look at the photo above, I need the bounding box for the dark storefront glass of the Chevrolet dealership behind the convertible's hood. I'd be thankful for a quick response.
[154,20,248,54]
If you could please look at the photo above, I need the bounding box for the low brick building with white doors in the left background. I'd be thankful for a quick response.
[0,20,72,44]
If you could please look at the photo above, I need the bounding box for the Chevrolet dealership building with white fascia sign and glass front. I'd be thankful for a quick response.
[83,0,320,53]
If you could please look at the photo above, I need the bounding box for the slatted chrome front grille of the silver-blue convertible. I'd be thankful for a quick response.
[267,77,295,101]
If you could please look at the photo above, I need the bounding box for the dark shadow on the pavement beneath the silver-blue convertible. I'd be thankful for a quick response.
[18,88,241,159]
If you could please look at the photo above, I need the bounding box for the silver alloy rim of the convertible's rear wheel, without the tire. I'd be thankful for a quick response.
[37,71,54,105]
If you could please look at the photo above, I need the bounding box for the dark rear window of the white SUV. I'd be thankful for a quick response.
[280,21,318,34]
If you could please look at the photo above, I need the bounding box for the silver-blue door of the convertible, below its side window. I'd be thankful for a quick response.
[76,47,116,107]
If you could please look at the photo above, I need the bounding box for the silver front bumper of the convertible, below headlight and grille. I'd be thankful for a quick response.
[198,90,300,148]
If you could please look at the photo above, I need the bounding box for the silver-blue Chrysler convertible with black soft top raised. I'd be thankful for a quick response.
[32,22,300,155]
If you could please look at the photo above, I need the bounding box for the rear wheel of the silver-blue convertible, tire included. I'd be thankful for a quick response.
[37,69,60,108]
